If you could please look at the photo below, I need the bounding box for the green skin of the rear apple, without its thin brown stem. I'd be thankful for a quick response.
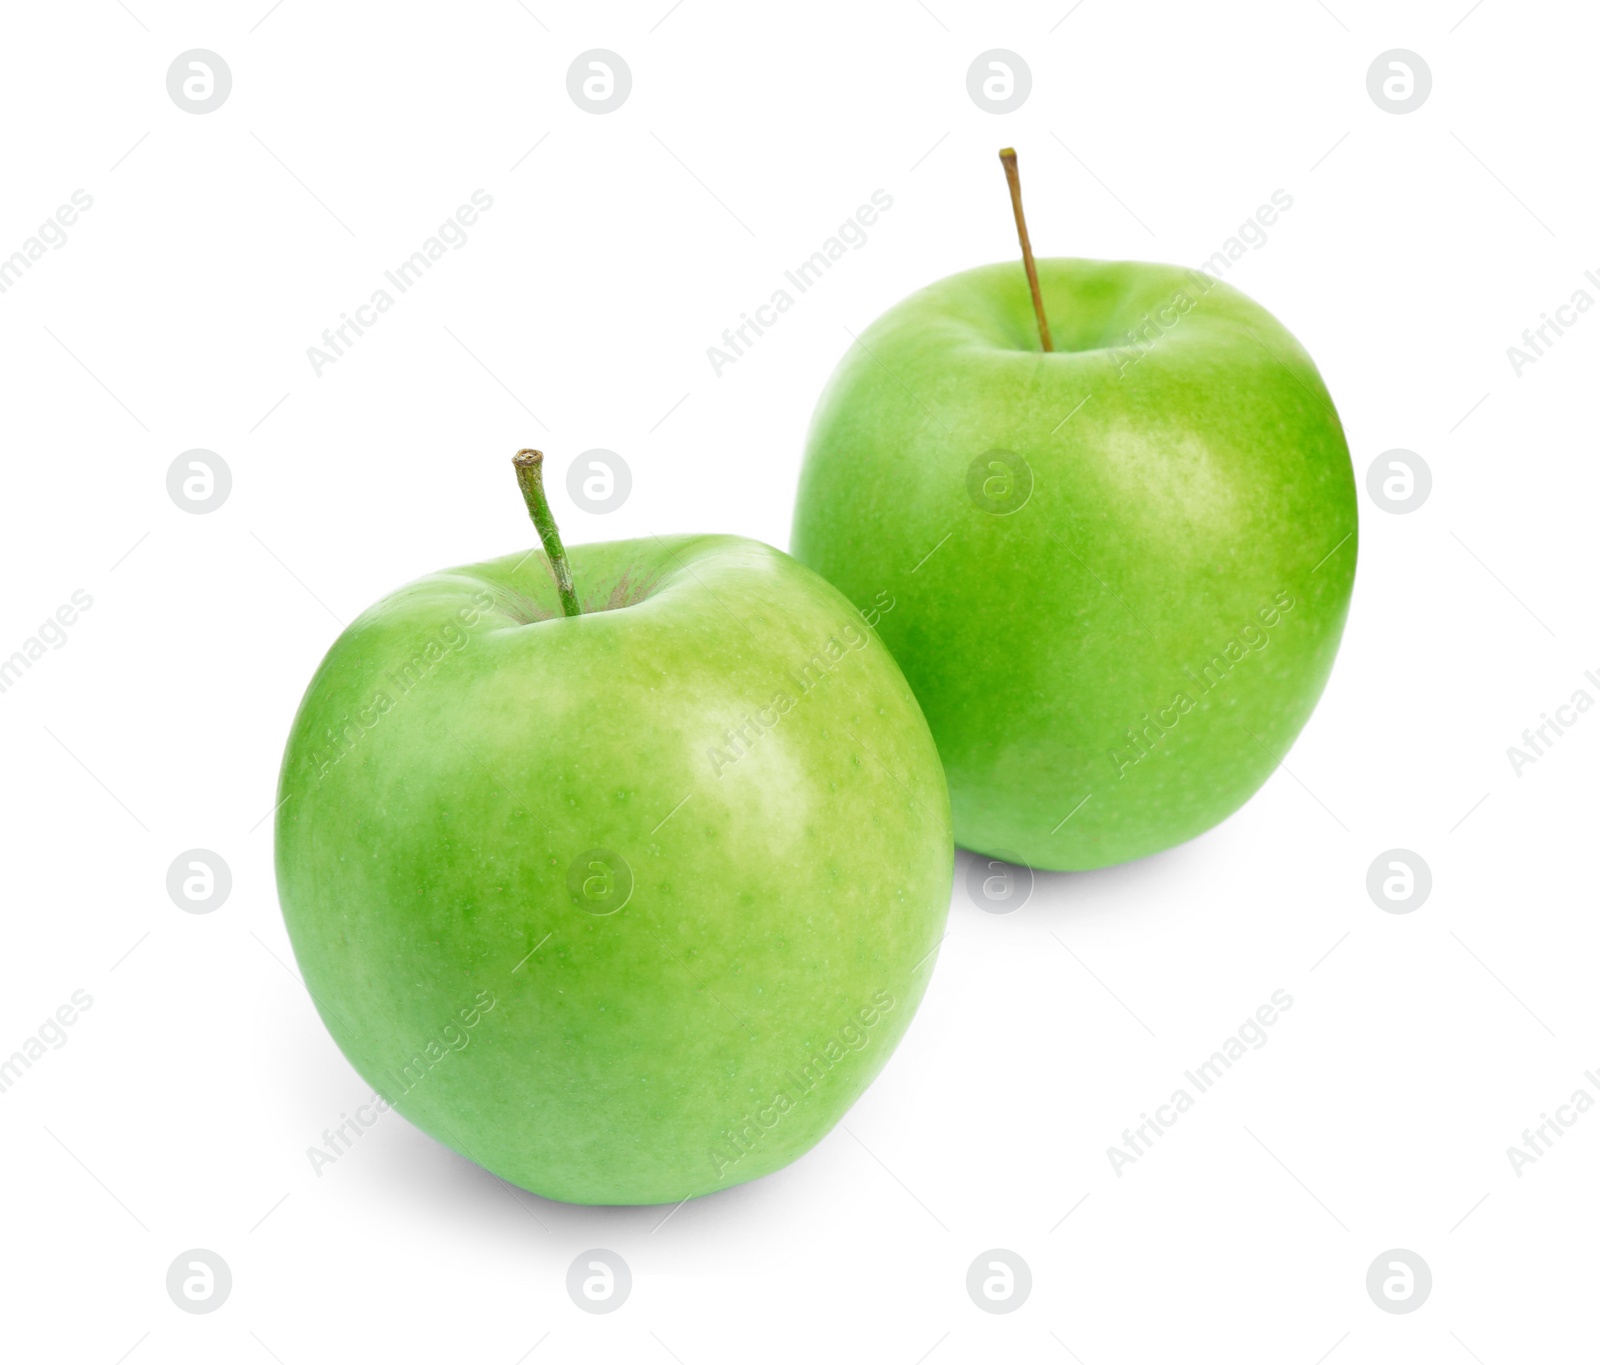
[792,259,1357,871]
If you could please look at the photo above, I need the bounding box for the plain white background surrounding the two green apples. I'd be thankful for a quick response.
[0,0,1600,1365]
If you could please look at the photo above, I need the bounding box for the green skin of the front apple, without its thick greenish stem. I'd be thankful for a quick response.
[277,536,954,1203]
